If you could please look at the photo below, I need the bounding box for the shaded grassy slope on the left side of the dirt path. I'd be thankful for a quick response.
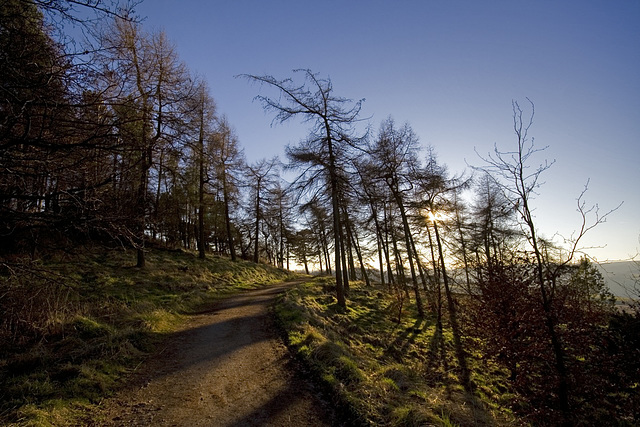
[0,250,290,426]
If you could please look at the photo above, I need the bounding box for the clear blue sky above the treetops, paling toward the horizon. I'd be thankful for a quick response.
[132,0,640,261]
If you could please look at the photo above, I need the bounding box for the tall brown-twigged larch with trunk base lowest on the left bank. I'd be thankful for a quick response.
[101,18,196,267]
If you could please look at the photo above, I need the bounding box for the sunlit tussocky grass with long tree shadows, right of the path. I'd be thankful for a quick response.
[276,278,522,426]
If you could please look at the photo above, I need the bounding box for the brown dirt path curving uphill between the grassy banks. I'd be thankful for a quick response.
[97,284,331,427]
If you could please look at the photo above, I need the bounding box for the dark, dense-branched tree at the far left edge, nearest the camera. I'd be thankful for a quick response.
[0,0,139,256]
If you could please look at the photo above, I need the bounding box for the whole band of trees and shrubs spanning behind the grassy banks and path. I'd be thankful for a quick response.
[0,0,640,425]
